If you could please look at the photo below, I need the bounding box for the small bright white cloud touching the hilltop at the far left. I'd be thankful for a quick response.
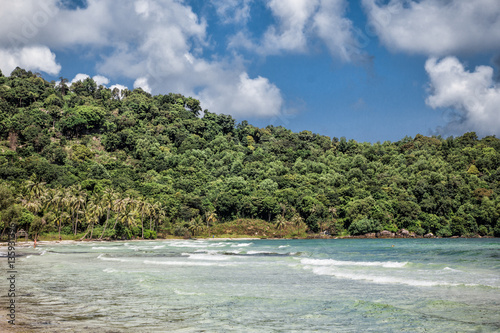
[0,45,61,75]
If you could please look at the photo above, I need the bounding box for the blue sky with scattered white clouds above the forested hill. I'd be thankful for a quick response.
[0,0,500,142]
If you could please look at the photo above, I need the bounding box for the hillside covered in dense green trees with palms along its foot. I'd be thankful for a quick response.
[0,68,500,238]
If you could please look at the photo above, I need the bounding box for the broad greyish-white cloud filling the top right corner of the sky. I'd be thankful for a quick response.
[363,0,500,56]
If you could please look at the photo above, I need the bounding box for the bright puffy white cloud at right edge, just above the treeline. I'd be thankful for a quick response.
[425,57,500,136]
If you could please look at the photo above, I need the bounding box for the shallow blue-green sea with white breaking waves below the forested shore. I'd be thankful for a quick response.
[0,239,500,332]
